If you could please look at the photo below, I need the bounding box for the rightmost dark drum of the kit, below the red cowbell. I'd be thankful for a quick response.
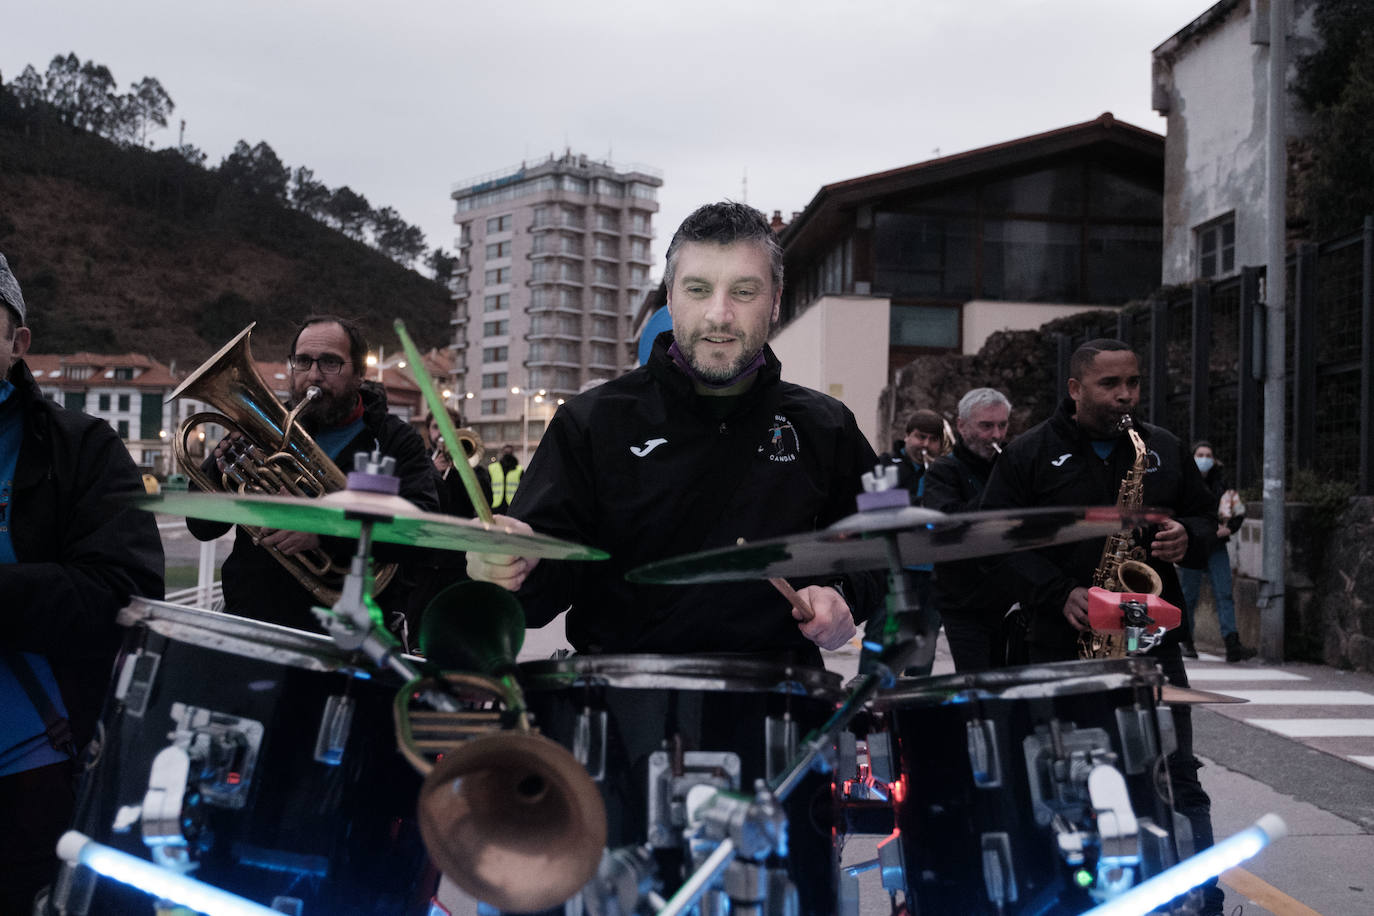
[868,658,1178,916]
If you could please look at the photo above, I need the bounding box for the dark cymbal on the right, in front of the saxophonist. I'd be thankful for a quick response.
[627,505,1169,585]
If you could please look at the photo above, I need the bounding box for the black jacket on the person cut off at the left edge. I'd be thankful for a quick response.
[0,360,164,747]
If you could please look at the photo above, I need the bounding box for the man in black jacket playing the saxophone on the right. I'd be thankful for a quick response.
[982,339,1223,916]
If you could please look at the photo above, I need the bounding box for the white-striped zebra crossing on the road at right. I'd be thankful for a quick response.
[1187,652,1374,769]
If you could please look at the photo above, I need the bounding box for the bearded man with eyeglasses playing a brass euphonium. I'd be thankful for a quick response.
[187,314,438,643]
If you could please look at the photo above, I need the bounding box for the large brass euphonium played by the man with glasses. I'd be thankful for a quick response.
[168,321,396,606]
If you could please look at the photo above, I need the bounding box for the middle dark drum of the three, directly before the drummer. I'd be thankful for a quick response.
[519,655,840,916]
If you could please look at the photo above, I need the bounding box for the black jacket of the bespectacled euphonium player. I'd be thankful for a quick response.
[185,382,440,632]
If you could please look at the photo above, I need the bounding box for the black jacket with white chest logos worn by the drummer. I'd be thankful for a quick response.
[511,332,882,665]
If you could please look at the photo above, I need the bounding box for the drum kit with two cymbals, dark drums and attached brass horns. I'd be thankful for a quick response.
[49,328,1264,916]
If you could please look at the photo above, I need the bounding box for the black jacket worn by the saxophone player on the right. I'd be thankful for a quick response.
[982,398,1217,658]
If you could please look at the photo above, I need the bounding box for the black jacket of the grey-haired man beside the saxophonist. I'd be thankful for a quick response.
[921,439,1014,619]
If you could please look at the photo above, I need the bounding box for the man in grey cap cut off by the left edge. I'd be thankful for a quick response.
[0,255,162,913]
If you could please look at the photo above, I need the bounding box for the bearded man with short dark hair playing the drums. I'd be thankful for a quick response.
[467,203,878,667]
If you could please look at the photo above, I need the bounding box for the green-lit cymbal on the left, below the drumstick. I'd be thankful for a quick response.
[135,490,607,560]
